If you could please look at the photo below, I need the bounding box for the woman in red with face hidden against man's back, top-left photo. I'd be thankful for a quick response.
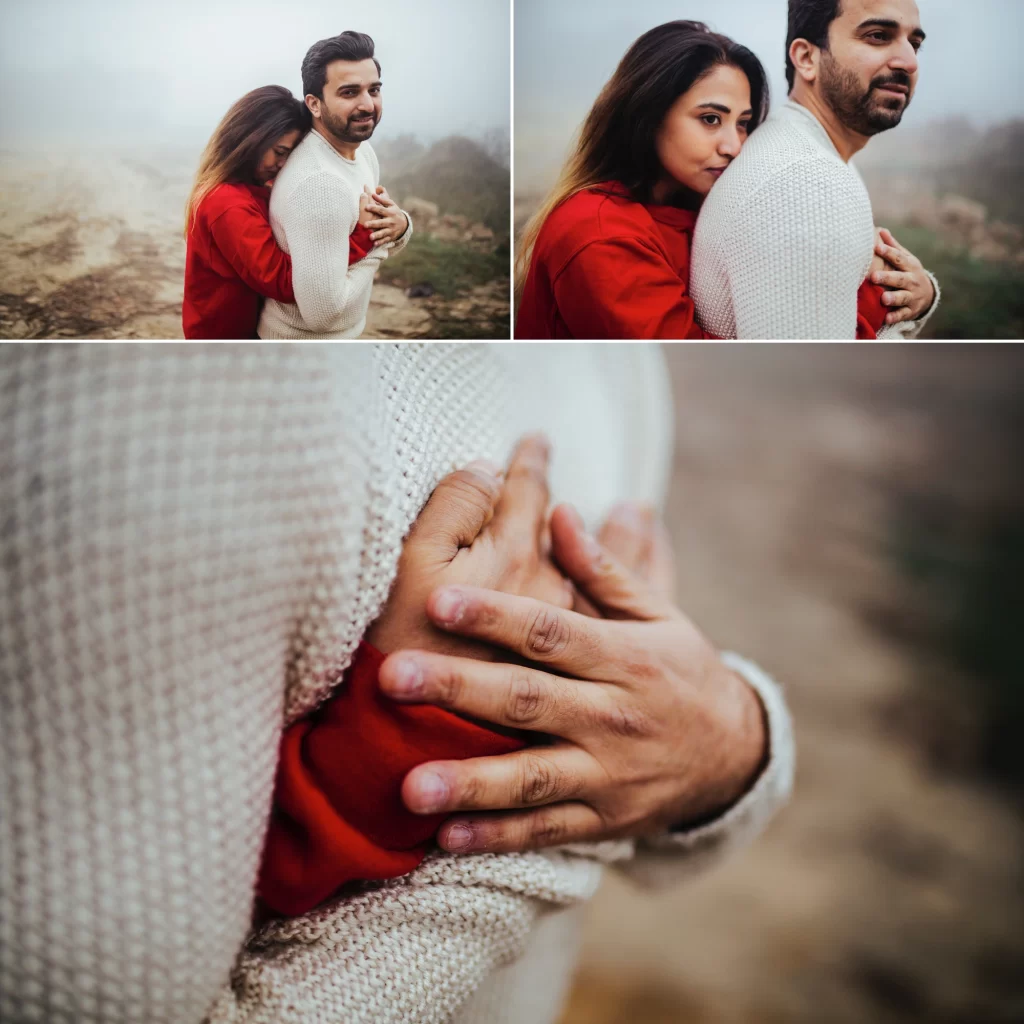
[181,85,373,339]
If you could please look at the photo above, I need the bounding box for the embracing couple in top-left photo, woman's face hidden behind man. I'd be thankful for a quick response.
[181,32,413,339]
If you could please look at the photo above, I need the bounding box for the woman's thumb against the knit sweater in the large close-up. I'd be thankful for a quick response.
[410,459,503,561]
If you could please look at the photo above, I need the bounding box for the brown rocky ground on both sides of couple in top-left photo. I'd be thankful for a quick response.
[0,151,509,339]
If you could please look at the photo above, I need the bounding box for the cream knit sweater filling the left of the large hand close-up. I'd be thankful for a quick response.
[0,344,793,1024]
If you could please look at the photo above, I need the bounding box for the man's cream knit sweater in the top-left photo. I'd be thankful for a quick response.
[258,131,413,339]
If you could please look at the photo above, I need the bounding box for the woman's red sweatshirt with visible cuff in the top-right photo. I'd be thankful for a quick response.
[515,181,888,340]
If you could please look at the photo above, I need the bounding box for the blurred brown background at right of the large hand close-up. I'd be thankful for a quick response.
[562,345,1024,1024]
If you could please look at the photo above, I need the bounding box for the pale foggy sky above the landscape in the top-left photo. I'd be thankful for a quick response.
[0,0,510,146]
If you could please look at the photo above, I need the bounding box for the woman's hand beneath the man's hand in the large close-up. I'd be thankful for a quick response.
[366,436,572,660]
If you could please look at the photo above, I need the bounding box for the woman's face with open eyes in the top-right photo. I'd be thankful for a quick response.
[655,65,754,198]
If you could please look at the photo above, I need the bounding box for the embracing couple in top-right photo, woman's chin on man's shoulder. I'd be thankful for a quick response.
[516,0,939,340]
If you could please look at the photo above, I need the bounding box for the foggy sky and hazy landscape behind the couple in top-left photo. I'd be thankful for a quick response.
[0,0,510,338]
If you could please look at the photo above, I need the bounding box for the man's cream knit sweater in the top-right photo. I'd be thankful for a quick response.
[690,100,939,341]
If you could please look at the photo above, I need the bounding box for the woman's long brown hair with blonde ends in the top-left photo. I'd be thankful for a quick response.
[184,85,312,238]
